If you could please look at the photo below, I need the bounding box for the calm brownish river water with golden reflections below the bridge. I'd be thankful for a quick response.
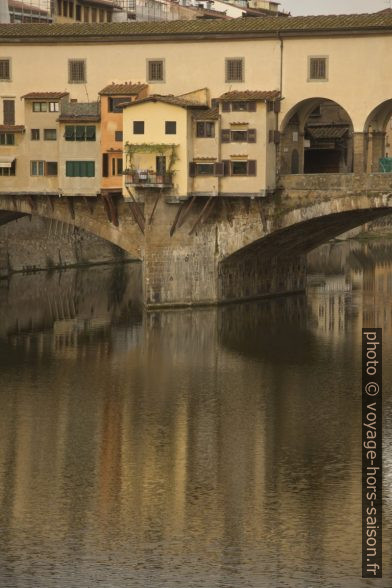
[0,241,392,588]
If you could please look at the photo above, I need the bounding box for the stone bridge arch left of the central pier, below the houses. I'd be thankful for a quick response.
[0,196,143,259]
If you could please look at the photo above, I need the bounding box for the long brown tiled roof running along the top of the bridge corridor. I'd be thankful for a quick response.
[0,12,392,43]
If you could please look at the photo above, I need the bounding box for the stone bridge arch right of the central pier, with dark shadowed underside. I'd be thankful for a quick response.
[218,191,392,301]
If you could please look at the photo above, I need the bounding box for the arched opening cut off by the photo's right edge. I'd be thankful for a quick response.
[364,99,392,173]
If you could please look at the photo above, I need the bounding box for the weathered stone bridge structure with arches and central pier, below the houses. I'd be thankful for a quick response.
[0,173,392,308]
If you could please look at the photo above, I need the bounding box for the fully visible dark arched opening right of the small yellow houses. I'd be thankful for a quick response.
[280,98,353,174]
